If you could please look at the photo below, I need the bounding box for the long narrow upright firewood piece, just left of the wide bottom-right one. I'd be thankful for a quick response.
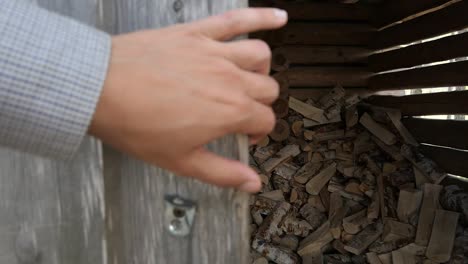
[415,183,442,246]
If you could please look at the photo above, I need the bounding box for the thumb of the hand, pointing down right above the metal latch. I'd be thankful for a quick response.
[182,148,262,192]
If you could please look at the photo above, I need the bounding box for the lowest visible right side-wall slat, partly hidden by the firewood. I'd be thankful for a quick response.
[421,145,468,177]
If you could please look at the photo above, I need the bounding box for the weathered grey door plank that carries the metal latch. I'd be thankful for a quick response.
[102,0,249,264]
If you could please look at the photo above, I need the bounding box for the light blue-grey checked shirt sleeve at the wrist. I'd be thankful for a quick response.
[0,0,111,158]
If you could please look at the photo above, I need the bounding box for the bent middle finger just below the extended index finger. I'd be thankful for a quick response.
[222,40,271,75]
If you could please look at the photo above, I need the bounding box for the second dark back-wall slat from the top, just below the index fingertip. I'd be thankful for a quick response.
[250,22,375,47]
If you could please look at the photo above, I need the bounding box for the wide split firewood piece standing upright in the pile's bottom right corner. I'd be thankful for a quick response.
[426,210,459,263]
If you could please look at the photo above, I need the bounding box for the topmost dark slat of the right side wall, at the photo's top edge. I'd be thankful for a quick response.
[373,0,450,27]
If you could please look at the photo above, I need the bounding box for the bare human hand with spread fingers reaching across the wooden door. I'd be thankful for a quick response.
[89,8,287,192]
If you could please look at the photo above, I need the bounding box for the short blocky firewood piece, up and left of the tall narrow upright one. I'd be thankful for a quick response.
[397,189,423,226]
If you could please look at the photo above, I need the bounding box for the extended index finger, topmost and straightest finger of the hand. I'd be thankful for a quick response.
[187,8,288,40]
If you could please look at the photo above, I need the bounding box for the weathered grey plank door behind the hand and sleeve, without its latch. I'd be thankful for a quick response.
[0,0,249,264]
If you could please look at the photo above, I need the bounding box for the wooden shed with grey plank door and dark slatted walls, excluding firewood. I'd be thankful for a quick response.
[0,0,468,264]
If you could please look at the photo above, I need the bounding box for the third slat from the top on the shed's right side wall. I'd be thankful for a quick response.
[369,33,468,72]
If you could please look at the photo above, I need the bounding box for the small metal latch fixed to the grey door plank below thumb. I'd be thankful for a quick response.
[164,195,196,236]
